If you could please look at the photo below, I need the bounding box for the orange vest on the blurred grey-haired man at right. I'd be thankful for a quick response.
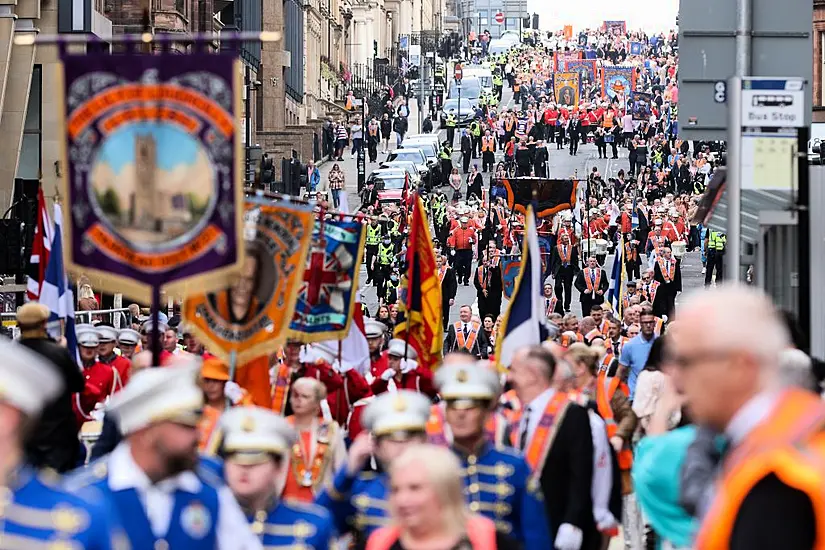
[693,389,825,550]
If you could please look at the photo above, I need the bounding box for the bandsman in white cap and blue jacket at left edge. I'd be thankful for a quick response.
[0,340,119,550]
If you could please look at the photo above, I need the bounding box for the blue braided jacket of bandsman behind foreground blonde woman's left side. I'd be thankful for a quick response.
[316,466,390,541]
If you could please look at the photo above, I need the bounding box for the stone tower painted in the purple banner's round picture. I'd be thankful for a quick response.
[129,134,163,231]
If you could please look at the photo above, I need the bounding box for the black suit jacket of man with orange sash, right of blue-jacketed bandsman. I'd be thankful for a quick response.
[540,403,598,550]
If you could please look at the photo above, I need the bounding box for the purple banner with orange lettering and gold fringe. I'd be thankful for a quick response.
[62,53,244,300]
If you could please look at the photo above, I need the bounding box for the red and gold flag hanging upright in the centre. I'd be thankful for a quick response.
[395,194,444,369]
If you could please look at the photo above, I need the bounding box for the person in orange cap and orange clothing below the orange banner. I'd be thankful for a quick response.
[198,357,252,454]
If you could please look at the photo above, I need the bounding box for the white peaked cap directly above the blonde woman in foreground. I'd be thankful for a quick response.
[361,390,432,436]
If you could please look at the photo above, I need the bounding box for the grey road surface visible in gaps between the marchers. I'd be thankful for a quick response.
[319,90,704,322]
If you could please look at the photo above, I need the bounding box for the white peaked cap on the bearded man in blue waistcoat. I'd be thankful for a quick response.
[108,362,203,435]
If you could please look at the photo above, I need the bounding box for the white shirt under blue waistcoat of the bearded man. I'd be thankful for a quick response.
[108,442,263,550]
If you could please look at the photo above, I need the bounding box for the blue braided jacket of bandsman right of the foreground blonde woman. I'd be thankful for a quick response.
[453,442,553,548]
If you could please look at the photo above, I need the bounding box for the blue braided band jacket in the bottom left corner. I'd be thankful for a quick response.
[0,466,124,550]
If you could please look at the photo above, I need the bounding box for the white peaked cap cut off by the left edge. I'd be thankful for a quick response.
[0,340,64,416]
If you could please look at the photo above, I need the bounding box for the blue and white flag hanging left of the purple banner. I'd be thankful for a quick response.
[40,204,80,364]
